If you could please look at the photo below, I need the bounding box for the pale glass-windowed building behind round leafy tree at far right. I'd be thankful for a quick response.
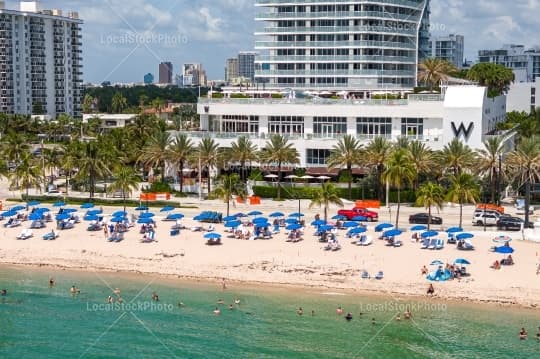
[478,45,540,82]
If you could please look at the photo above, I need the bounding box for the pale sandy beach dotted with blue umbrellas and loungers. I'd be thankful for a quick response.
[0,190,540,307]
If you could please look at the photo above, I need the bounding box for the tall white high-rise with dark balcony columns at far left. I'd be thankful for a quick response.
[0,1,83,117]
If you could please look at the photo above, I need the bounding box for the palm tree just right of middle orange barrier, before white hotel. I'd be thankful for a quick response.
[259,134,300,200]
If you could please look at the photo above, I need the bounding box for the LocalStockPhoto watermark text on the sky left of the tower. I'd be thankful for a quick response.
[100,32,188,46]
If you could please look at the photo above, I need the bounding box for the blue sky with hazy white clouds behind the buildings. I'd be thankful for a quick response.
[6,0,540,83]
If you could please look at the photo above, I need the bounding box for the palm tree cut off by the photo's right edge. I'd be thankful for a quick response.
[505,135,540,224]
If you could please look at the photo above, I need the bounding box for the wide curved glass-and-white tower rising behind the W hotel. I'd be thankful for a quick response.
[255,0,431,90]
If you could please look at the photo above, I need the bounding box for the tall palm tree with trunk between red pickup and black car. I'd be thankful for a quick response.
[382,149,415,228]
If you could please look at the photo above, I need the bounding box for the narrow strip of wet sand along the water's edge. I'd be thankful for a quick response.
[0,261,538,310]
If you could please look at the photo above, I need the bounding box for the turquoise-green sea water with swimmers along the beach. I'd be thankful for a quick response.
[0,267,540,358]
